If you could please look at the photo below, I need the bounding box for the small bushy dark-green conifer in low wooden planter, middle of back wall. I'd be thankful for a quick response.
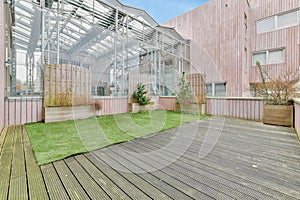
[129,83,153,113]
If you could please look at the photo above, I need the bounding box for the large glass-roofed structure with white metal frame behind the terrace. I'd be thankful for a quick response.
[6,0,190,96]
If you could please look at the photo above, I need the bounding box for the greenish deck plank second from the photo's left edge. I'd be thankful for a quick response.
[8,126,28,200]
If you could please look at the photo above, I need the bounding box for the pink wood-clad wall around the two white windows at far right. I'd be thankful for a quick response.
[250,0,300,82]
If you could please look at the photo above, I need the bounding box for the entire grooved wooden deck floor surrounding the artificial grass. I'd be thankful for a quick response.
[0,118,300,199]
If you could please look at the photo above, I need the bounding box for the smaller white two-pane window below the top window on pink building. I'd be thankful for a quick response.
[252,49,284,66]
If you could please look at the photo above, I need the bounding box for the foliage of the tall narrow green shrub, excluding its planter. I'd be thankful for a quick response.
[176,72,195,103]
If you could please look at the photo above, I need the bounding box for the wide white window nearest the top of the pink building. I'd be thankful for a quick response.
[256,9,300,34]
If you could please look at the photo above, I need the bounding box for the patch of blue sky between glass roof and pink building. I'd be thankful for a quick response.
[119,0,209,24]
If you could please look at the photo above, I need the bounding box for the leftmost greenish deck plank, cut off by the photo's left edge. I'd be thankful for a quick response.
[0,126,15,199]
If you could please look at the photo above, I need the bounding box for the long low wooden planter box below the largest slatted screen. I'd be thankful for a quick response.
[44,105,94,123]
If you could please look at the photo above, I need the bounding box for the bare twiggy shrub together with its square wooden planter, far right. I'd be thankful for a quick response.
[255,62,299,126]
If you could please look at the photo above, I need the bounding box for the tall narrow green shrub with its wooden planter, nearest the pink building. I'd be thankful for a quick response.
[175,72,200,113]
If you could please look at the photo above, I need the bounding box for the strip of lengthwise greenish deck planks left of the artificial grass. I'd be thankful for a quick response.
[0,126,49,199]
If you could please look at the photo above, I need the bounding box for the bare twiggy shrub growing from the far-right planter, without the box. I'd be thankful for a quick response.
[254,61,299,105]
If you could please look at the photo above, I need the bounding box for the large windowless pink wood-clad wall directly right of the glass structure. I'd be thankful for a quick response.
[165,0,251,96]
